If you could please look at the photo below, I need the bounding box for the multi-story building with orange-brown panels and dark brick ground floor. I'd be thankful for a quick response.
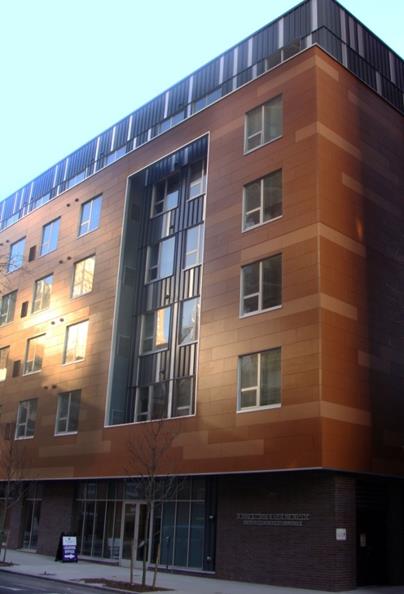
[0,0,404,590]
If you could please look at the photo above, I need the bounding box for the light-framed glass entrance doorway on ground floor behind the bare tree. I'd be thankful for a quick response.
[121,501,148,567]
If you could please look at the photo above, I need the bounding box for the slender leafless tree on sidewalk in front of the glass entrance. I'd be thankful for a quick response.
[126,419,179,588]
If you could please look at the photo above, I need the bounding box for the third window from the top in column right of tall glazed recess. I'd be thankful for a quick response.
[241,254,282,315]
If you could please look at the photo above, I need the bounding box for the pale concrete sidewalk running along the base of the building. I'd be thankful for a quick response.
[1,550,404,594]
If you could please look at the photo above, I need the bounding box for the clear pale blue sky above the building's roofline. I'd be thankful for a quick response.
[0,0,404,200]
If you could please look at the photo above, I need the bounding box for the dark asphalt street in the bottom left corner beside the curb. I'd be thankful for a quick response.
[0,571,110,594]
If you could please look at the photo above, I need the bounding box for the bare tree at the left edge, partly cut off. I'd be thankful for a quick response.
[0,423,28,562]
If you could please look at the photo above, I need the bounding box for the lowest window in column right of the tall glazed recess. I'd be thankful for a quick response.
[238,348,281,410]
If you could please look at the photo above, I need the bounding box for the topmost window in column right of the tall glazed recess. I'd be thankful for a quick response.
[244,96,282,151]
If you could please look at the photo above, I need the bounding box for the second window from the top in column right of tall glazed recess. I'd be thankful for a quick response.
[243,171,282,230]
